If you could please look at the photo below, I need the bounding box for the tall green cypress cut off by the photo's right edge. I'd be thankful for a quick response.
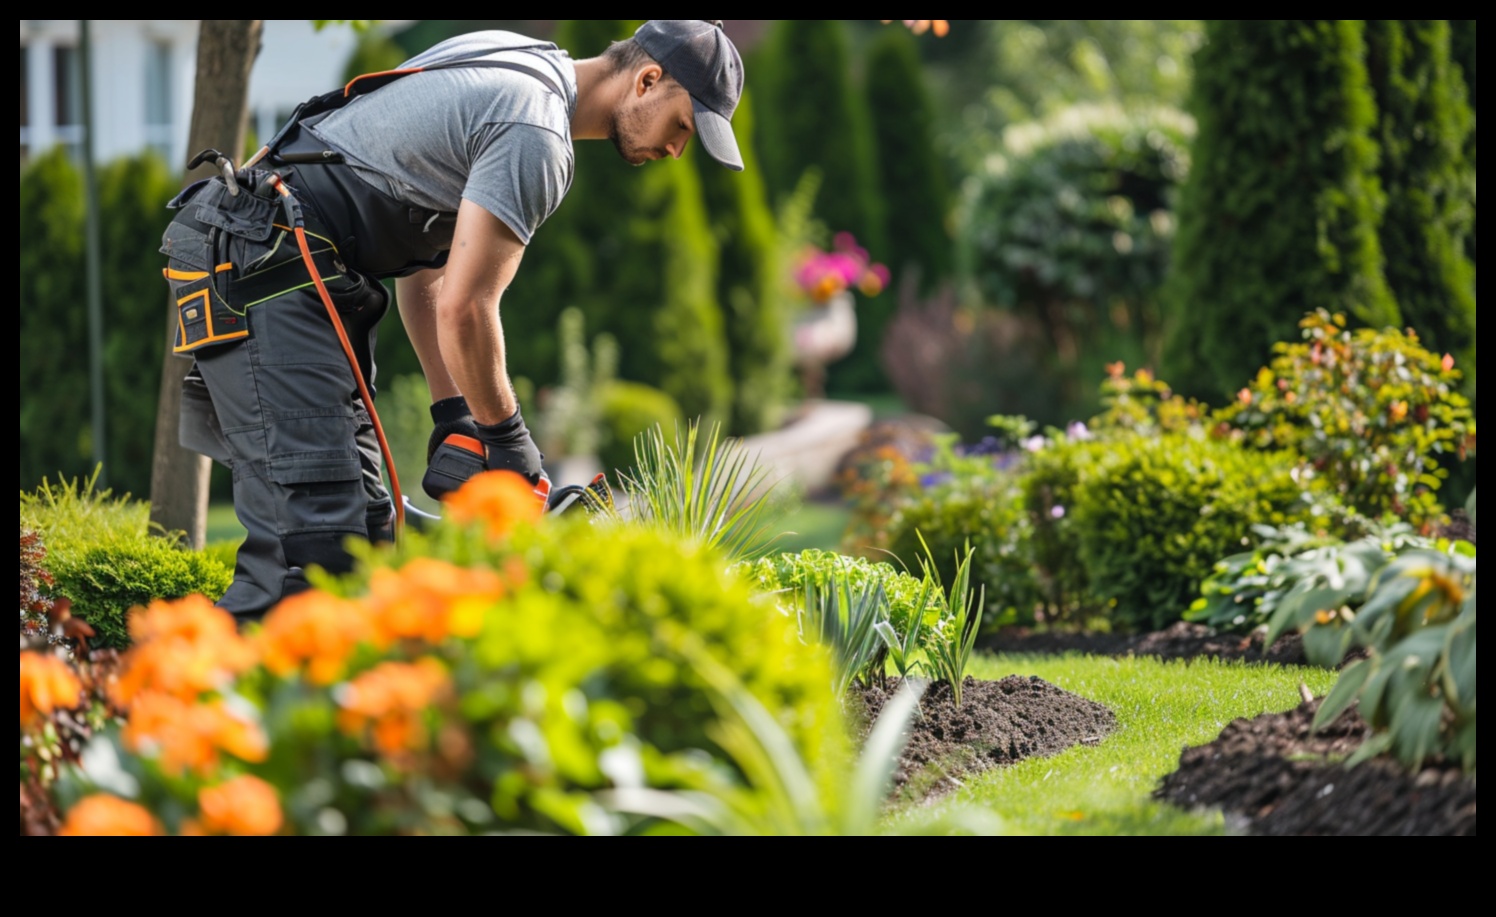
[1366,19,1475,367]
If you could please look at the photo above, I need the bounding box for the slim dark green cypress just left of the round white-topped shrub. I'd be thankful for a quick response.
[868,28,954,291]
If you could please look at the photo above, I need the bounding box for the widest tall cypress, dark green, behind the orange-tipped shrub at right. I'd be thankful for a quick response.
[1165,19,1400,398]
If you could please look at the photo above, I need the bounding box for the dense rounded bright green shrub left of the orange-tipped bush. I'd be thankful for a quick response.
[1071,434,1312,630]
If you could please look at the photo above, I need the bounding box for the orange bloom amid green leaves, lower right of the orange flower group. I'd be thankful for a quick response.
[338,658,450,757]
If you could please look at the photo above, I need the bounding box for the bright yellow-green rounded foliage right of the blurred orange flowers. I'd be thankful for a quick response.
[340,516,845,805]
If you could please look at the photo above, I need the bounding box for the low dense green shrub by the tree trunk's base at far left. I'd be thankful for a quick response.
[51,536,233,649]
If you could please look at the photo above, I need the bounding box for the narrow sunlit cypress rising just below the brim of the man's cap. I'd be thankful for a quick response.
[690,93,791,435]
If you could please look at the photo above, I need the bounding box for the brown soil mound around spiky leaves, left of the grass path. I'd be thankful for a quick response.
[860,675,1116,800]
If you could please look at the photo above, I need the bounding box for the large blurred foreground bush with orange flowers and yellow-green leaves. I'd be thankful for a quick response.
[32,473,842,836]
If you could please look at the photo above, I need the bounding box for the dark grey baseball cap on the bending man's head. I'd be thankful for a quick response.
[634,19,744,172]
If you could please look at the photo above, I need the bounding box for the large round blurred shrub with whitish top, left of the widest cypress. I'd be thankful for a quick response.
[957,105,1194,423]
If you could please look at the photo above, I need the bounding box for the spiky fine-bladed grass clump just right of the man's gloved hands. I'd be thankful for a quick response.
[622,420,776,559]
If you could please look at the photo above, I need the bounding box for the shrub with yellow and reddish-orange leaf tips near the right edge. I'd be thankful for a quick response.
[1216,311,1475,527]
